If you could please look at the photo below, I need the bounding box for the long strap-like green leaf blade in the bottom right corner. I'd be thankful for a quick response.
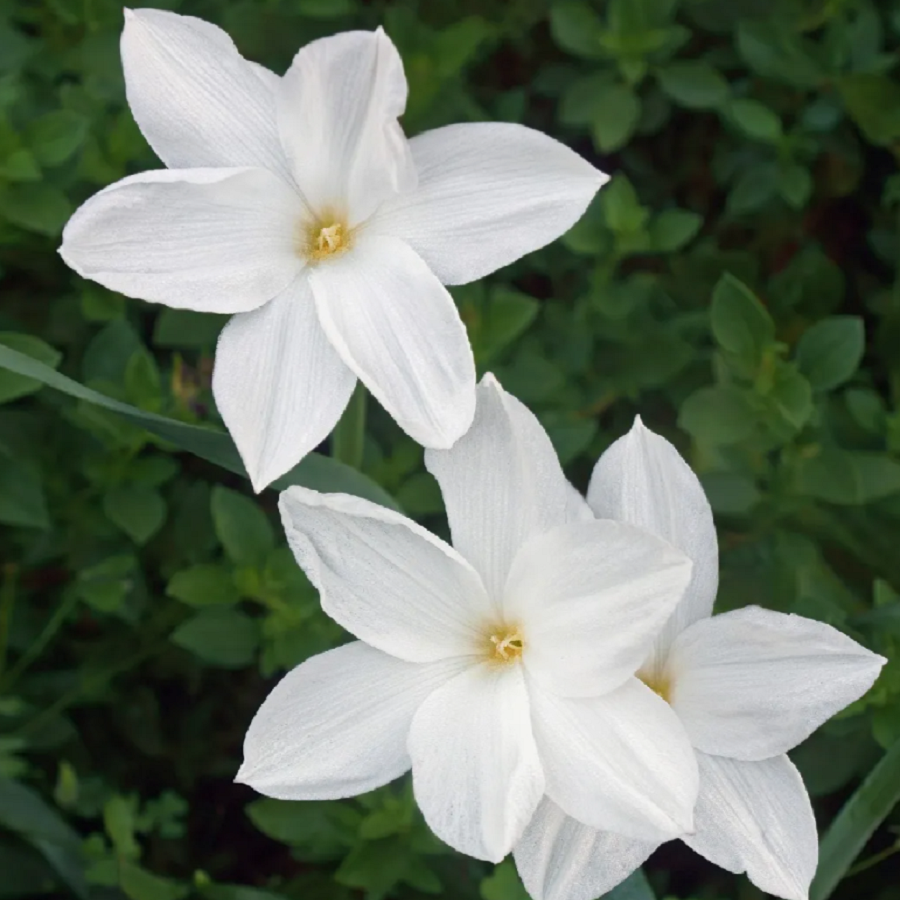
[809,741,900,900]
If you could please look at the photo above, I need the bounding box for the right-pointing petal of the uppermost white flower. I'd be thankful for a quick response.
[372,122,608,284]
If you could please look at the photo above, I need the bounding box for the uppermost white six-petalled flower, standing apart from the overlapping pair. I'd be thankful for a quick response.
[60,9,606,490]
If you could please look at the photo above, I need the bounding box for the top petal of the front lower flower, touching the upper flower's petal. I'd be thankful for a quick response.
[425,375,571,599]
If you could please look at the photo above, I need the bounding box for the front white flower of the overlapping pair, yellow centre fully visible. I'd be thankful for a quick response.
[238,376,697,861]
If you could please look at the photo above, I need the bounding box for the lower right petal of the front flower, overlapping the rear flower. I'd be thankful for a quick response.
[529,678,697,842]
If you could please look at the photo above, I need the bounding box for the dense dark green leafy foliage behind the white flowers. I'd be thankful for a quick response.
[0,0,900,900]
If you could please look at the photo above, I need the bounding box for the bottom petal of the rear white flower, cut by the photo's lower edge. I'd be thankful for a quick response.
[513,797,659,900]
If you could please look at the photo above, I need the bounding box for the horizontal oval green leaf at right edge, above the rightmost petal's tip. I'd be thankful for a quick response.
[796,447,900,506]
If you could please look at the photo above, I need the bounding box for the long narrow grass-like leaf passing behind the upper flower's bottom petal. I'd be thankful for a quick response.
[0,344,397,509]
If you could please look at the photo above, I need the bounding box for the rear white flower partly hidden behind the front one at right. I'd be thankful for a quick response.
[515,419,885,900]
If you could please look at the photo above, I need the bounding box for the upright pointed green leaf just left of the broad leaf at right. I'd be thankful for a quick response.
[710,272,775,372]
